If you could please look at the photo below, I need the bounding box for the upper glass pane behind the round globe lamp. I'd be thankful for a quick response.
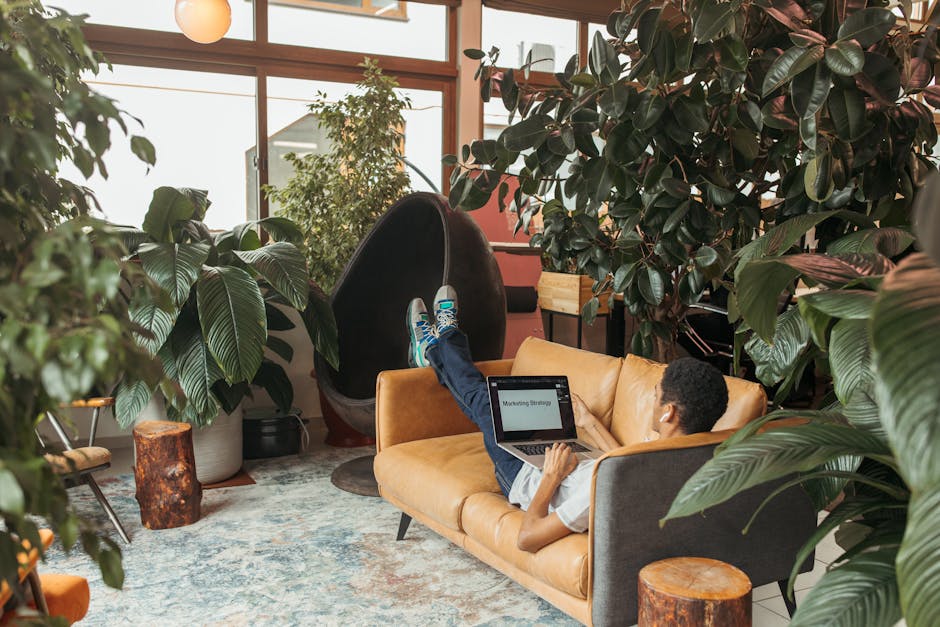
[47,0,254,39]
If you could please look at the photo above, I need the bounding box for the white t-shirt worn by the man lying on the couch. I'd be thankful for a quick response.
[509,459,597,533]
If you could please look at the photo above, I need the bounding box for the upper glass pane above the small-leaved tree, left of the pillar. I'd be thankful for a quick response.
[268,0,447,61]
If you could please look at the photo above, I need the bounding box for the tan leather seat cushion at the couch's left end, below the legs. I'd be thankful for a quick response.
[375,432,500,531]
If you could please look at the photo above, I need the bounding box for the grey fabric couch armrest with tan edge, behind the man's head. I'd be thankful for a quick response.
[588,424,816,626]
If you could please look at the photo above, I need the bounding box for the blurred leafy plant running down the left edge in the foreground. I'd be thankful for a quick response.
[0,0,159,604]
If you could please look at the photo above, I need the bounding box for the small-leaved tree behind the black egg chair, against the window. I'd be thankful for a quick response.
[264,59,411,292]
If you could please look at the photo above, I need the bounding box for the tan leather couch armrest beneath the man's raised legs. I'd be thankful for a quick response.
[375,359,512,451]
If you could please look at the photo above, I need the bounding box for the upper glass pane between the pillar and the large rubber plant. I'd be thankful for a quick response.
[483,7,578,72]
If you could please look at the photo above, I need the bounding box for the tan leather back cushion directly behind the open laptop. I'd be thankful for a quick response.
[512,337,623,440]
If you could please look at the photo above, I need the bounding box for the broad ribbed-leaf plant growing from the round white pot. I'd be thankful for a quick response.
[115,187,338,427]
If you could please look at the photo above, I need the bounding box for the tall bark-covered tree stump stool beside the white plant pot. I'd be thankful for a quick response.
[134,420,202,529]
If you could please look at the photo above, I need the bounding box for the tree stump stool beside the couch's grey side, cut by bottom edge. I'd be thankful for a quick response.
[637,557,751,627]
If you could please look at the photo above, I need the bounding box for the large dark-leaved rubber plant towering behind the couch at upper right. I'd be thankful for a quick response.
[445,0,940,359]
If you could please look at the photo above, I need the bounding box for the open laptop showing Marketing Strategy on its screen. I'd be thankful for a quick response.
[486,376,604,469]
